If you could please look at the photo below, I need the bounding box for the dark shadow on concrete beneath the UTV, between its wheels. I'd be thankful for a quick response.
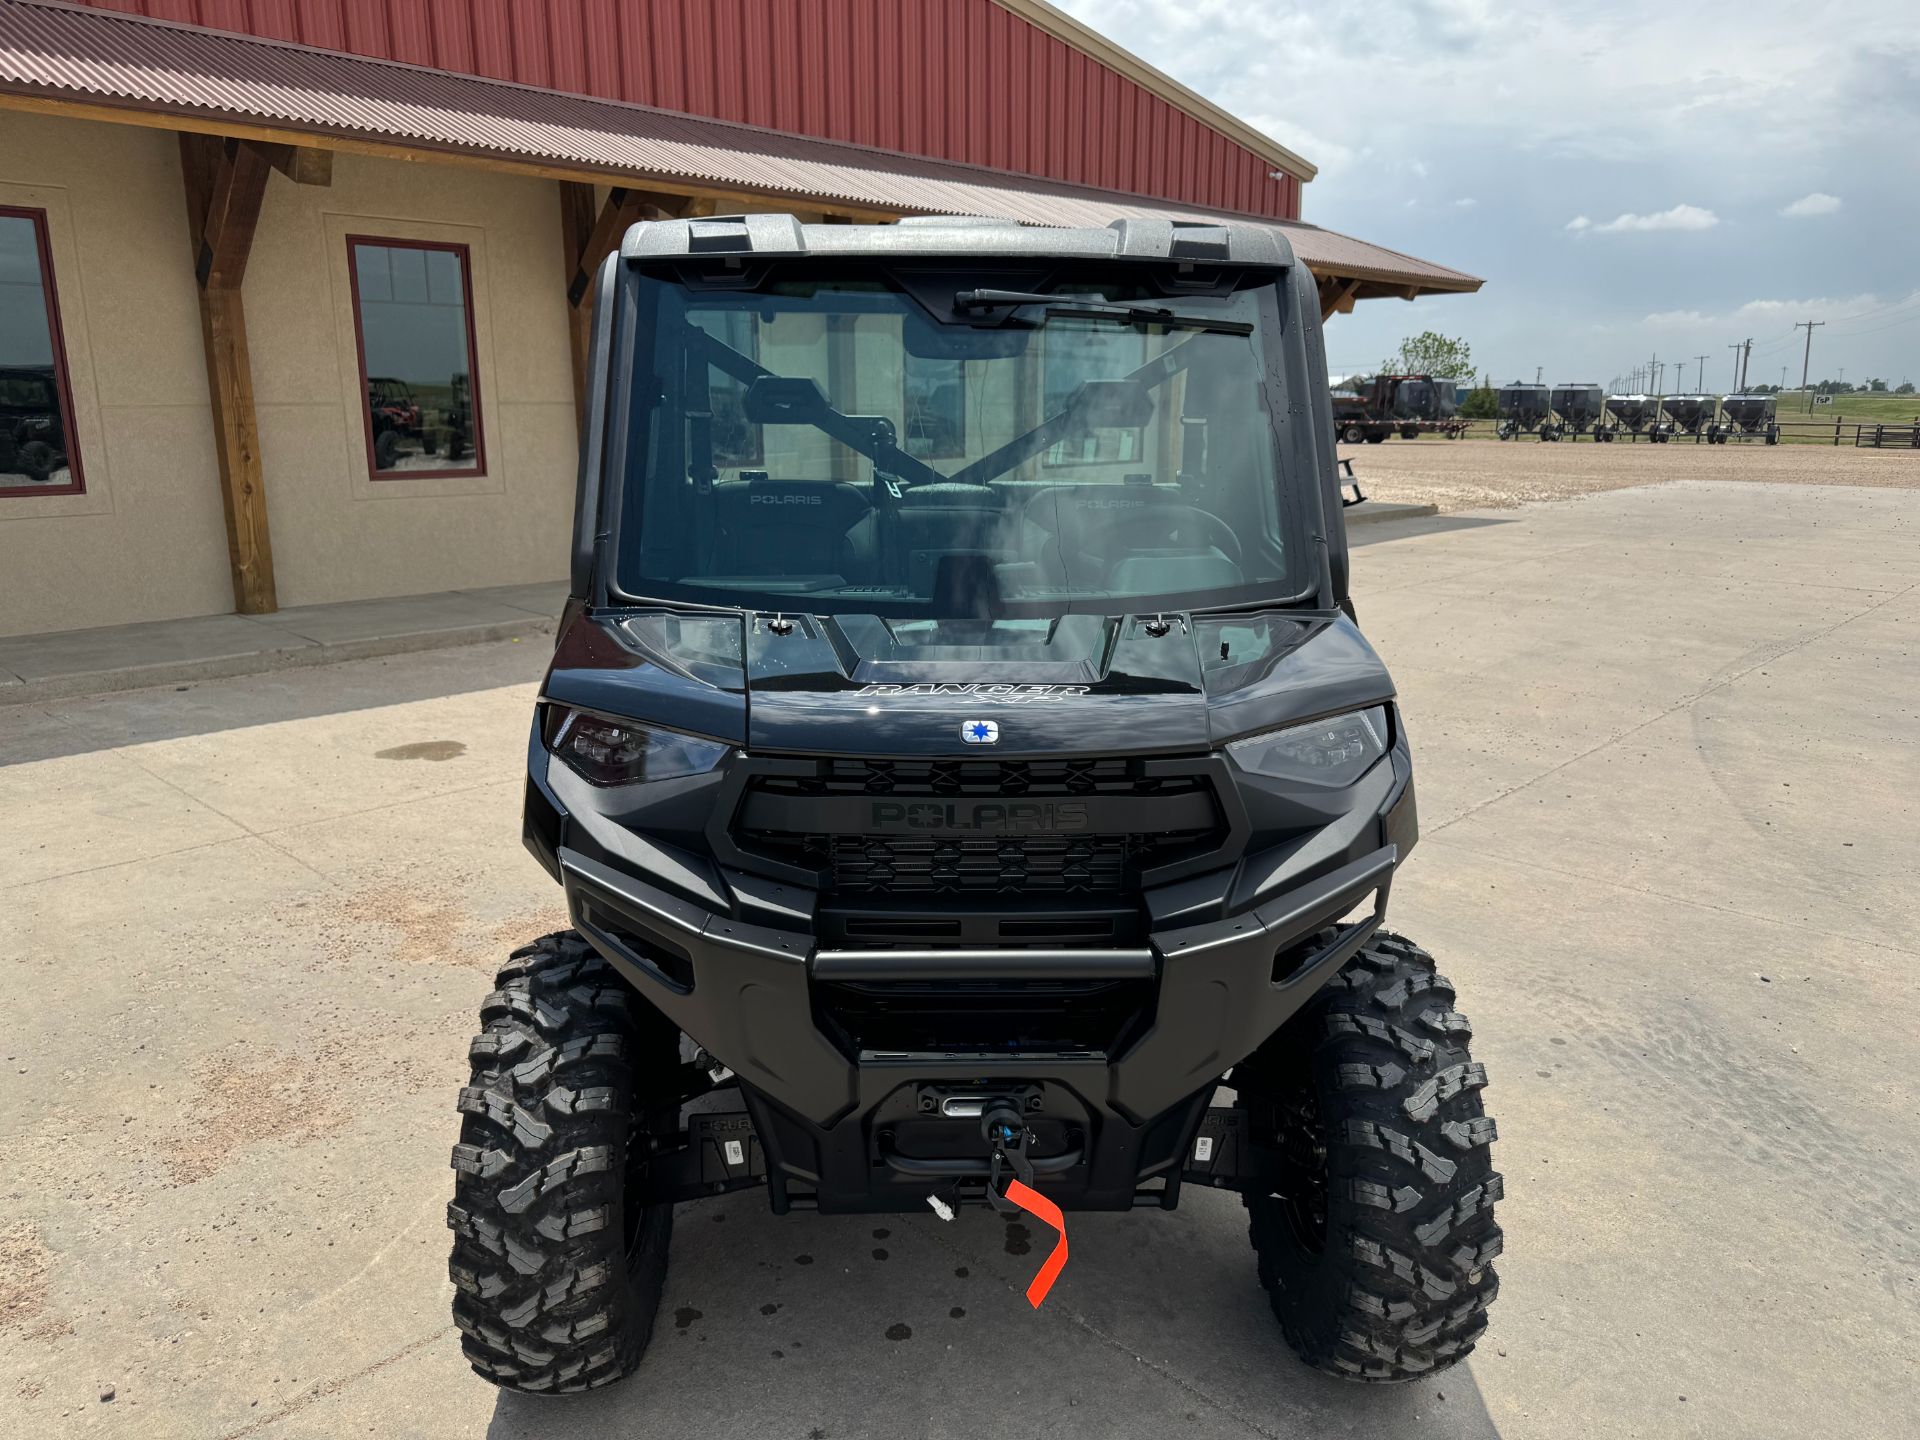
[476,1192,1500,1440]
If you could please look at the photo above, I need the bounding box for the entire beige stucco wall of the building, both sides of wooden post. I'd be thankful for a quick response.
[0,111,576,634]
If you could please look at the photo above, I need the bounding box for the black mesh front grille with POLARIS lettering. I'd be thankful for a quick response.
[735,756,1221,899]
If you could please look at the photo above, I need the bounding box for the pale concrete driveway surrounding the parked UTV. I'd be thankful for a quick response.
[0,484,1920,1440]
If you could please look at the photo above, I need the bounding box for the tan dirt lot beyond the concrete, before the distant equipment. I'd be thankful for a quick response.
[1340,436,1920,513]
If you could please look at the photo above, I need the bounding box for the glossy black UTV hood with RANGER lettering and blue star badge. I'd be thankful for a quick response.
[545,611,1394,758]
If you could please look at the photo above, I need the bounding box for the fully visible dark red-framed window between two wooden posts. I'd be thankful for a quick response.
[348,236,486,480]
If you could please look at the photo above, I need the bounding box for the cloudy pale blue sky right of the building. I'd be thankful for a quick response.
[1056,0,1920,392]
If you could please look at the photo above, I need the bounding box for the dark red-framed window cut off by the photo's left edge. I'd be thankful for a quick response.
[0,205,84,495]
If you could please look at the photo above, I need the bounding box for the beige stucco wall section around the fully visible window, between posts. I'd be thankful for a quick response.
[246,156,576,605]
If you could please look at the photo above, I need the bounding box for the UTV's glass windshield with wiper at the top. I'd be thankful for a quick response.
[614,269,1309,620]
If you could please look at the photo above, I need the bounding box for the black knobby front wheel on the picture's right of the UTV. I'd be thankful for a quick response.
[1229,931,1501,1382]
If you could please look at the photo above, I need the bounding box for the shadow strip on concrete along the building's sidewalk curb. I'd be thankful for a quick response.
[0,634,553,766]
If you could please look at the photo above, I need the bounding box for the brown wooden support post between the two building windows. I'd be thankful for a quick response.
[180,134,280,614]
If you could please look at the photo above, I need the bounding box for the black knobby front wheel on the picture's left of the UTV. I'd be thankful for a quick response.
[447,931,687,1394]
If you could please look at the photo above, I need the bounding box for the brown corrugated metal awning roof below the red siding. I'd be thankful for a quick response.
[0,0,1480,294]
